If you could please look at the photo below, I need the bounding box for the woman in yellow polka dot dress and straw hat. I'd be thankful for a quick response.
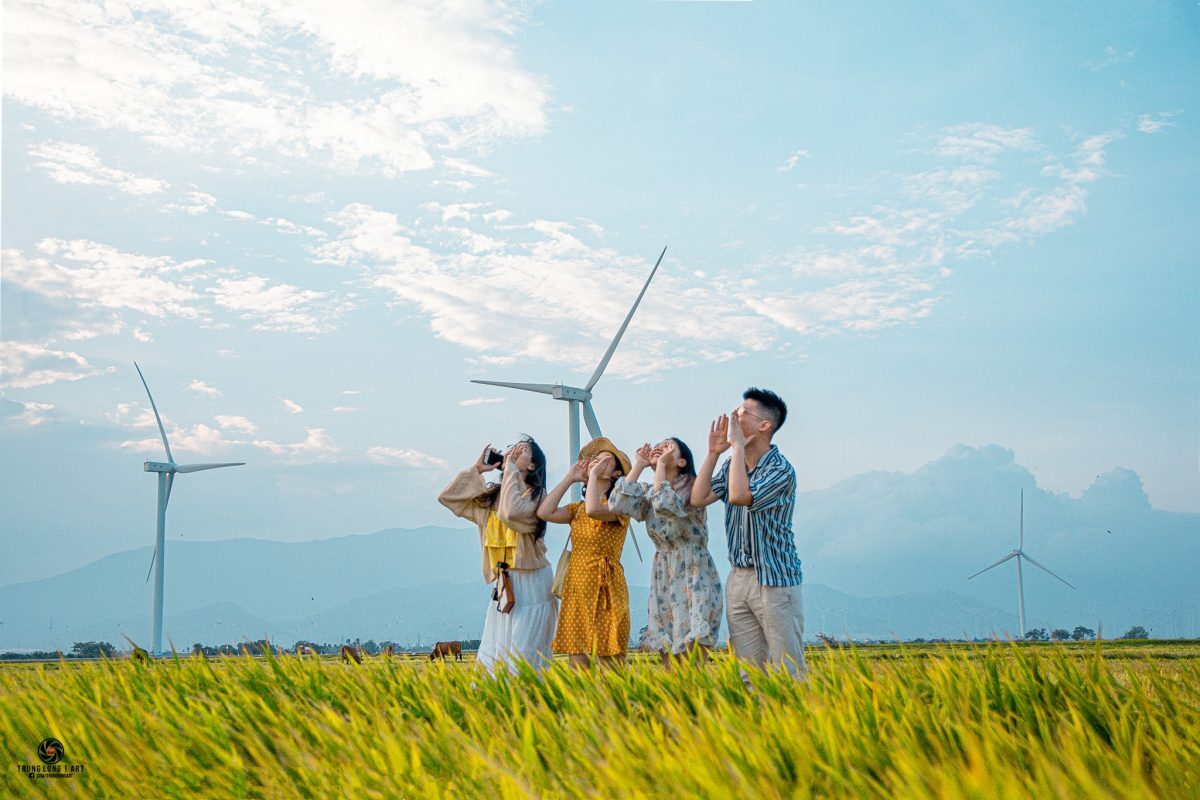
[538,437,630,668]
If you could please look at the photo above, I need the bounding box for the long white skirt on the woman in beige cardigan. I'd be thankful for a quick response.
[476,566,558,673]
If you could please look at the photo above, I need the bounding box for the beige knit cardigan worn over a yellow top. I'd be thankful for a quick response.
[438,464,550,583]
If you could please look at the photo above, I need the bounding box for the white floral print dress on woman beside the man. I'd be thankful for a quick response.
[610,476,724,654]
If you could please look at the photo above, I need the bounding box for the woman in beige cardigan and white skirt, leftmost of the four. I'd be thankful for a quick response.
[438,437,558,672]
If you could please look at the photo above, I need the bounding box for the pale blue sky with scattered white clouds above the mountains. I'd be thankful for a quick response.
[0,0,1200,582]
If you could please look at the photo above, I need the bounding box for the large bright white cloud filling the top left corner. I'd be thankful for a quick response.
[5,0,548,176]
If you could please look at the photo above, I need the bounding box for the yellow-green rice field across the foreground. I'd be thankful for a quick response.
[0,643,1200,800]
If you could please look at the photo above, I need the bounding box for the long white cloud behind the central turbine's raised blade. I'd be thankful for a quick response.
[313,204,770,375]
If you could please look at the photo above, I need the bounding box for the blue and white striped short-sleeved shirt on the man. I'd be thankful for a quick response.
[713,445,803,587]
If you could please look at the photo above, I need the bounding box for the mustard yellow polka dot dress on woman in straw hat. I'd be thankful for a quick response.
[552,500,629,656]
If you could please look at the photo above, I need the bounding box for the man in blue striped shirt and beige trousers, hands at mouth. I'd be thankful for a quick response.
[691,389,808,679]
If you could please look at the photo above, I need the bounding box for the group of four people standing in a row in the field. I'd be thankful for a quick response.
[438,387,806,678]
